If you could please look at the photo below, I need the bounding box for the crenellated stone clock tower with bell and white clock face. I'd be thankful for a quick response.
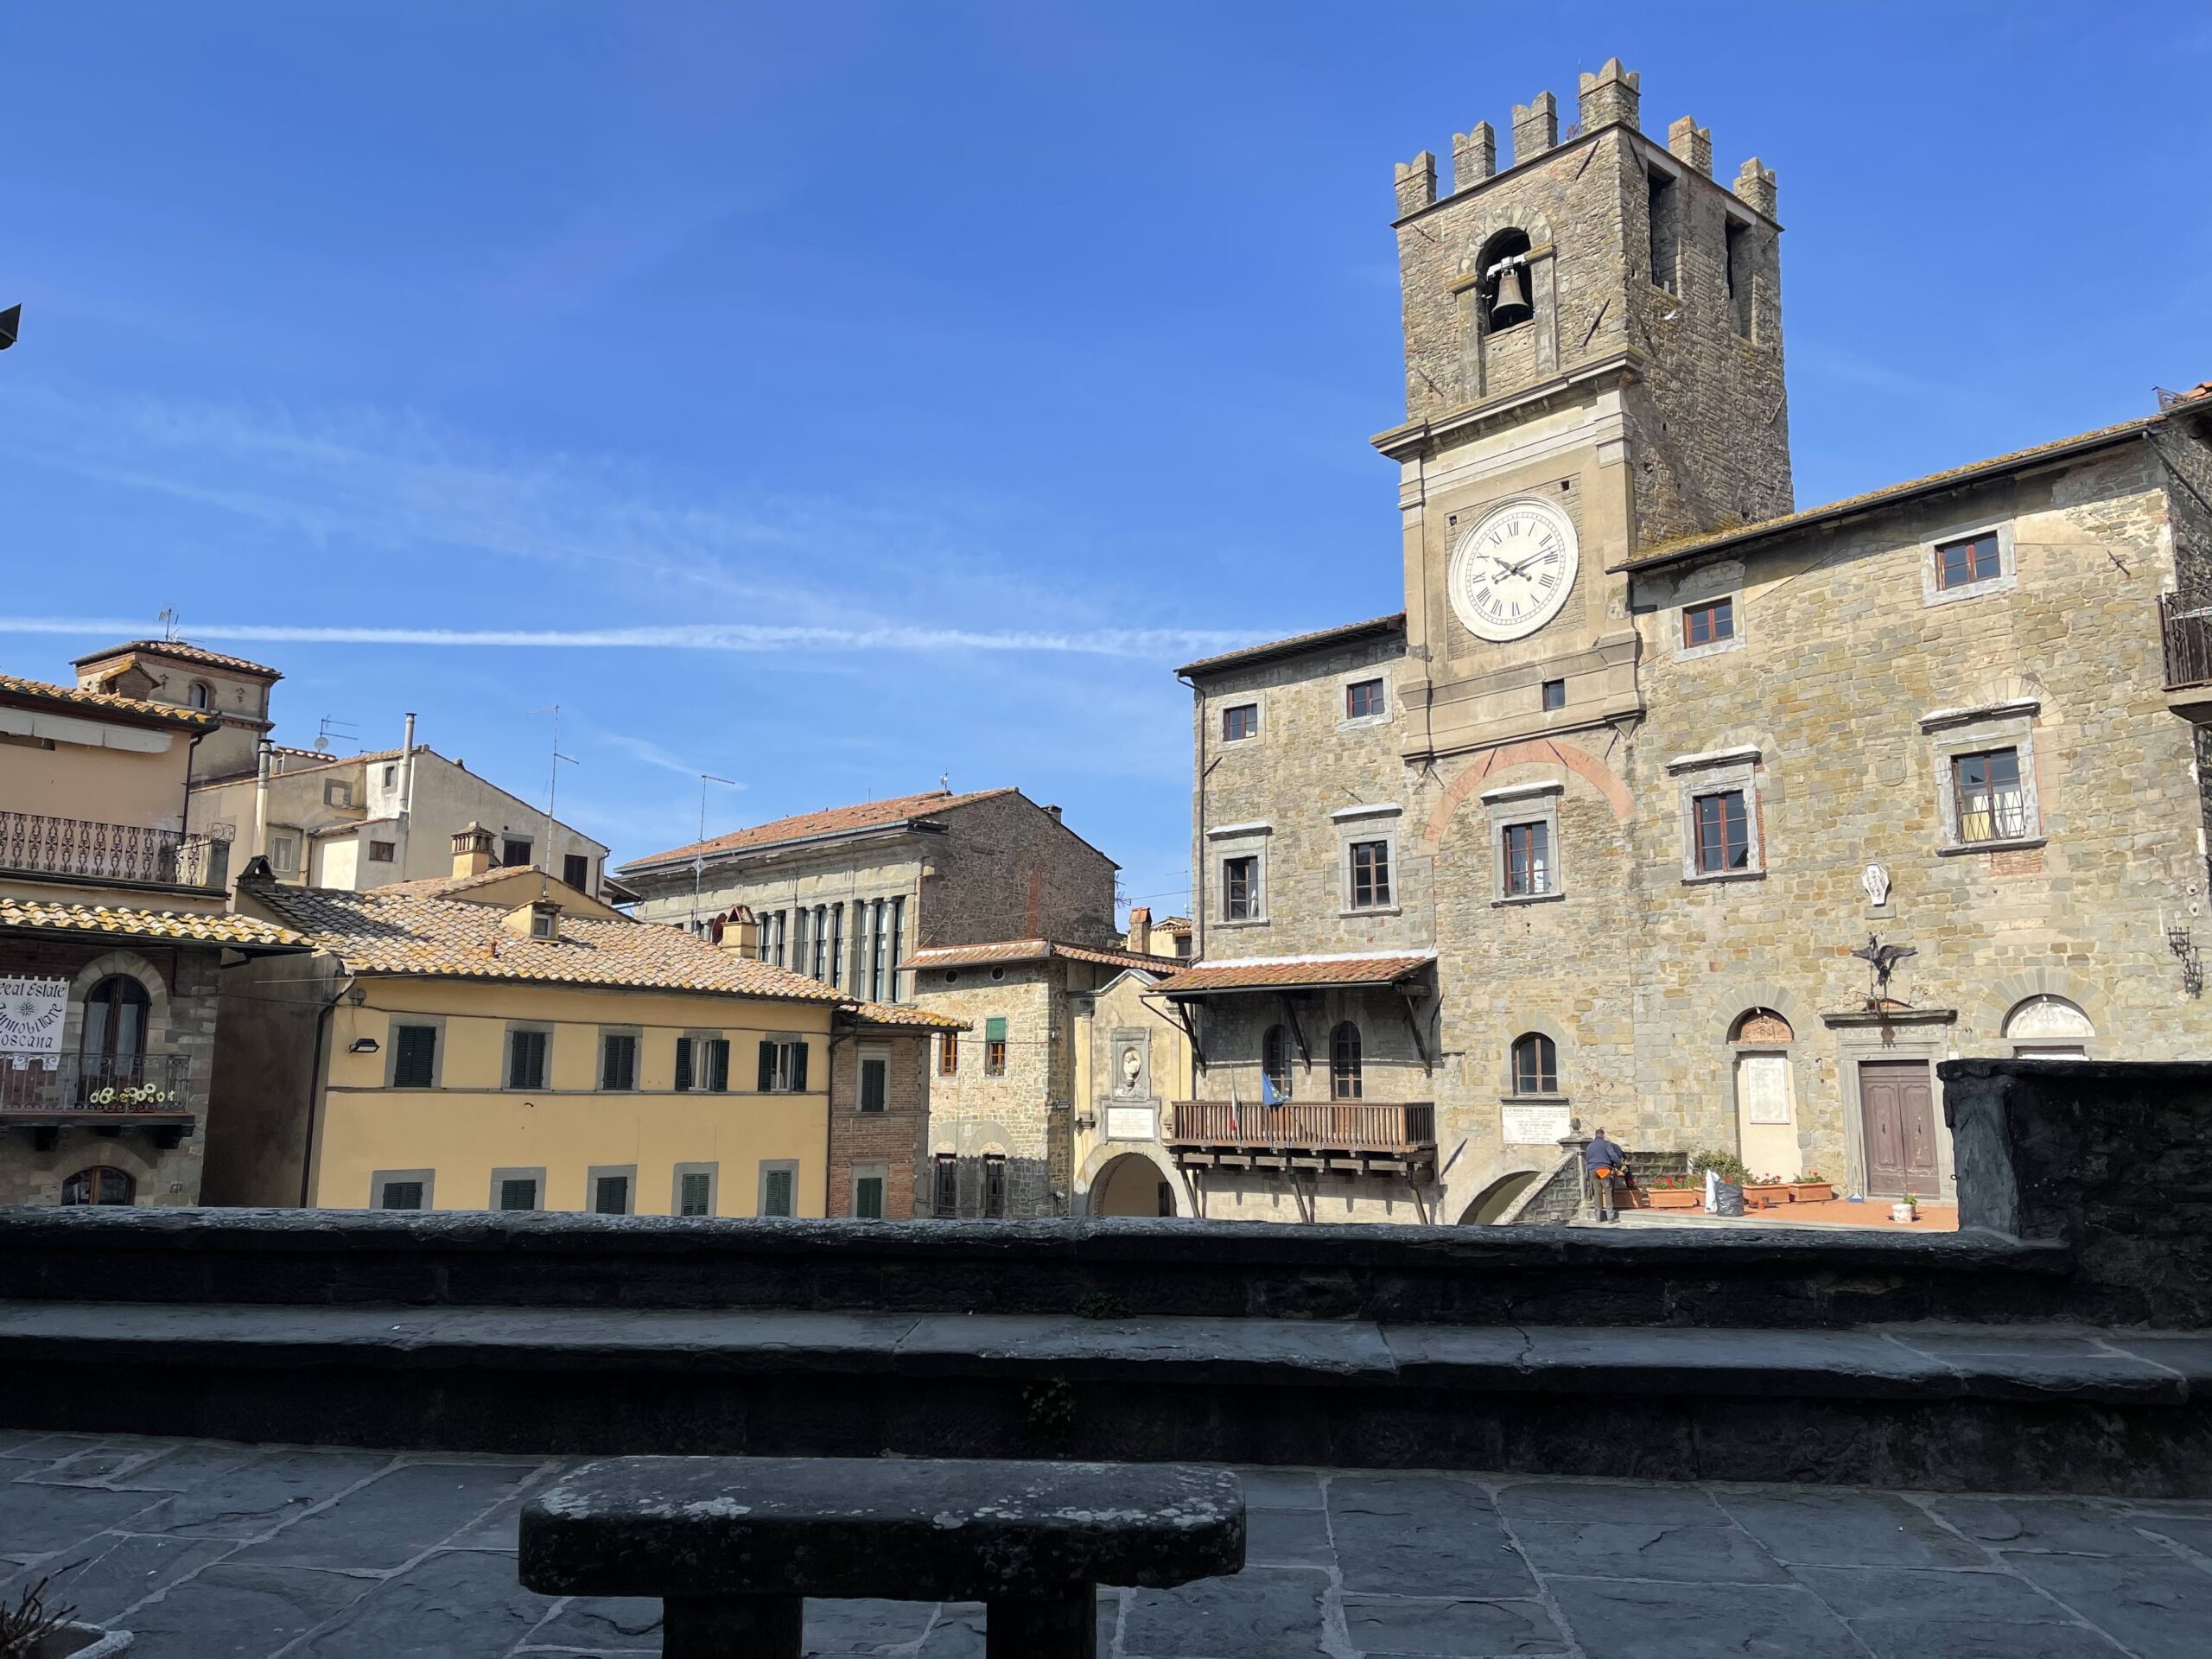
[1376,60,1792,763]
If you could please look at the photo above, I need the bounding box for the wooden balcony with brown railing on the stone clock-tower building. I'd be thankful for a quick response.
[1168,1099,1435,1177]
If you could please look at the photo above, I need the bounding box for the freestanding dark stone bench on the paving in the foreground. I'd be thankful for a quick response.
[520,1458,1245,1659]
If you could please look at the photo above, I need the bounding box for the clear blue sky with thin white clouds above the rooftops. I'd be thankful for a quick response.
[0,0,2212,909]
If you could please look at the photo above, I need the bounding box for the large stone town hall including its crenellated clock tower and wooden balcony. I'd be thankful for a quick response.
[1154,62,2212,1221]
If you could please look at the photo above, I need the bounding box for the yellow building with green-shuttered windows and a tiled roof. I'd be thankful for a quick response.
[206,830,847,1217]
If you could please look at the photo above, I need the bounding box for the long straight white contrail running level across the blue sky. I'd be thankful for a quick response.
[0,617,1274,657]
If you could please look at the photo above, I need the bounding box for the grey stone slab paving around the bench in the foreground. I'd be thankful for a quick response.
[0,1431,2212,1659]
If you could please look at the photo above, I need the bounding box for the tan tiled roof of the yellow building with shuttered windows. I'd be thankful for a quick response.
[252,872,841,1002]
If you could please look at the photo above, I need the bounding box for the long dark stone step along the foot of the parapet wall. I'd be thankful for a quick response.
[0,1300,2212,1497]
